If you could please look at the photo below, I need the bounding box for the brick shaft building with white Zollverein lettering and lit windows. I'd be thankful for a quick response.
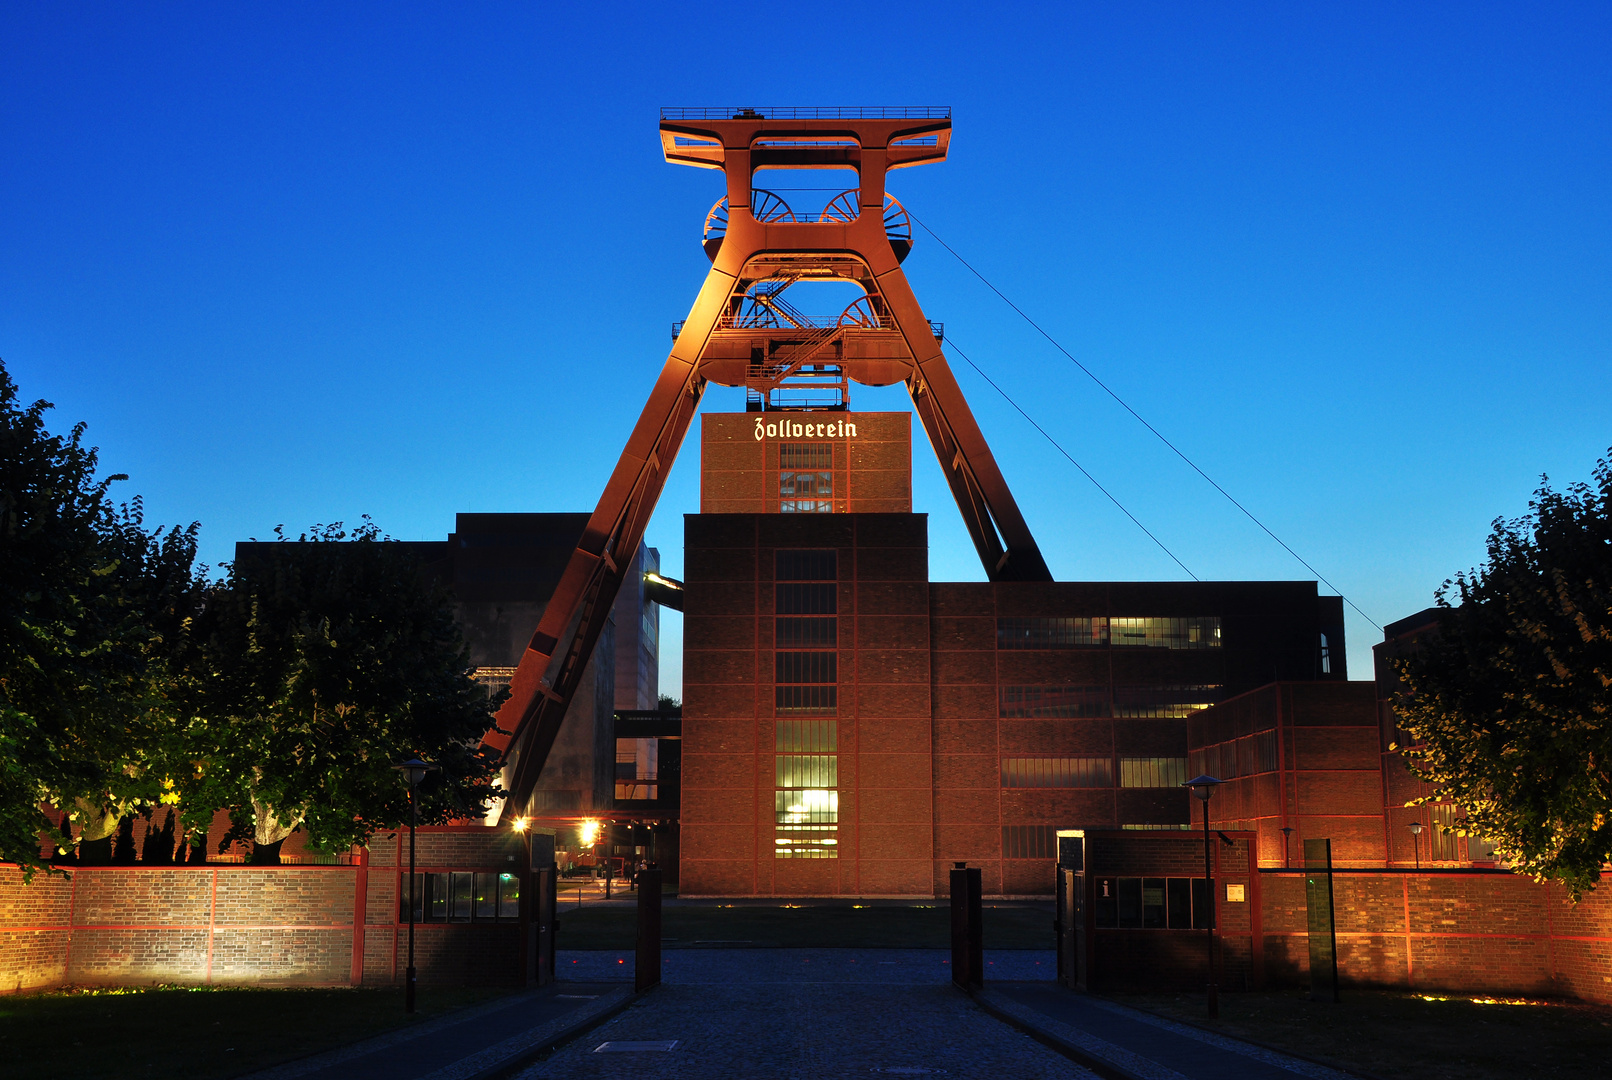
[682,411,1347,896]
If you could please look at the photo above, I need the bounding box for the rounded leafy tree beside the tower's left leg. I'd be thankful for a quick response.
[199,519,498,862]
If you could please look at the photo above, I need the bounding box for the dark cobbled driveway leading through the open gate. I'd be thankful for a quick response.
[253,948,1349,1080]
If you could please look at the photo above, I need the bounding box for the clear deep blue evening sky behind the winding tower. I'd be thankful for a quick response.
[0,0,1612,693]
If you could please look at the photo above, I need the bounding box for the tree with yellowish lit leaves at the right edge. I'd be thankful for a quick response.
[1394,458,1612,901]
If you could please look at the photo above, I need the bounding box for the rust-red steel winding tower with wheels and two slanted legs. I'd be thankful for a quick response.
[485,108,1051,812]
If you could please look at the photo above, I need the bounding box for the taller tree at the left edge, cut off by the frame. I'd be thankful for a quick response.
[0,364,200,874]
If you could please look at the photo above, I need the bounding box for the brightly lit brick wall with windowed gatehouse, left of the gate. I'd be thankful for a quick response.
[0,825,527,993]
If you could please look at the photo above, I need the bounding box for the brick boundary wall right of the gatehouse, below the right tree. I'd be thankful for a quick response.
[1259,869,1612,1003]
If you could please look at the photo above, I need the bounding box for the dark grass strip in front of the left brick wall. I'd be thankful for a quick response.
[0,987,508,1080]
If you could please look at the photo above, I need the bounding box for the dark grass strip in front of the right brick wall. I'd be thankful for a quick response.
[1114,990,1612,1080]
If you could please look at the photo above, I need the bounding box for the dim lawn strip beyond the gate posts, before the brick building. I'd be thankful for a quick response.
[556,901,1054,949]
